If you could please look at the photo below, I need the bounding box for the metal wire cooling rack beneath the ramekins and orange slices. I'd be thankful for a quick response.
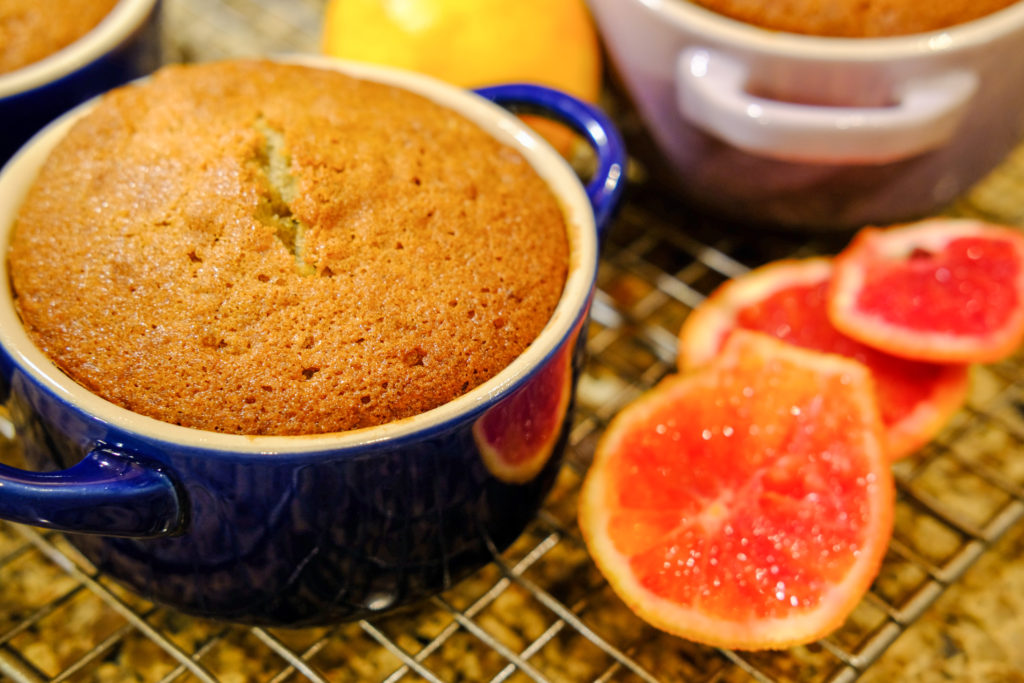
[0,0,1024,683]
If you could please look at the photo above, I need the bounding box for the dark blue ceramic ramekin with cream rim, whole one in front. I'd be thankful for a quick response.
[0,57,626,626]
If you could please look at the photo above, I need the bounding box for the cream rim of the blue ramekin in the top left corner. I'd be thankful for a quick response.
[0,0,157,97]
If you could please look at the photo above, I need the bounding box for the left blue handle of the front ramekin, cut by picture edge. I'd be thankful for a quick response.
[0,446,186,538]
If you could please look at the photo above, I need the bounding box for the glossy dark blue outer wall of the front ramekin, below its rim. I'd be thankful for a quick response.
[0,81,625,626]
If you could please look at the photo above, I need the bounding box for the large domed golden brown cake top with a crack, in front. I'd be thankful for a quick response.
[8,57,568,434]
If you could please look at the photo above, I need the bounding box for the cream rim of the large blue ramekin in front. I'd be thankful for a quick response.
[0,55,597,455]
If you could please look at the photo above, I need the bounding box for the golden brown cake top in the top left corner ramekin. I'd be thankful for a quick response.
[0,0,118,74]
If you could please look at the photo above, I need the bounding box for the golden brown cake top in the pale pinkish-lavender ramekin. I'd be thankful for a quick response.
[693,0,1016,38]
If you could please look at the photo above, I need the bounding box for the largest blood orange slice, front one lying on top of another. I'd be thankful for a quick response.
[579,330,894,649]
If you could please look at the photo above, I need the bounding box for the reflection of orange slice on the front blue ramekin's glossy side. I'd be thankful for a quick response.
[473,343,572,483]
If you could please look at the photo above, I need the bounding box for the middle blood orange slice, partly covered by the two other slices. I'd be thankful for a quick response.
[679,258,969,460]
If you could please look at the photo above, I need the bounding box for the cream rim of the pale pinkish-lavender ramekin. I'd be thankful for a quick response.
[643,0,1024,62]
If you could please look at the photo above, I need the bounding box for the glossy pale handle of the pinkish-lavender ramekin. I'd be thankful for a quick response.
[676,47,978,165]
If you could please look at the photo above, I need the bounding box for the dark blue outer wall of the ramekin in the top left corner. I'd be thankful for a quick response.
[0,2,162,164]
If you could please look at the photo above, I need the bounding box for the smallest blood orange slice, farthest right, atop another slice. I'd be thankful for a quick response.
[828,218,1024,362]
